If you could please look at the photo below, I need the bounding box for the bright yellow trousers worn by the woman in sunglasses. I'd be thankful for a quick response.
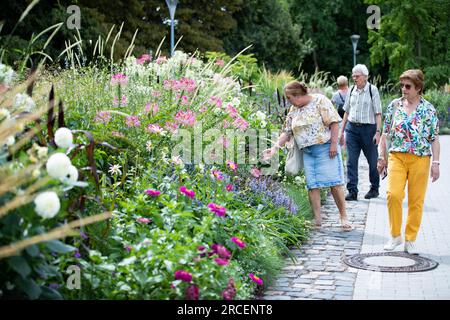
[387,152,430,241]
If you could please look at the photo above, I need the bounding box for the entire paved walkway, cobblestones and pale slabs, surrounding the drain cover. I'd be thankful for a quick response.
[263,136,450,300]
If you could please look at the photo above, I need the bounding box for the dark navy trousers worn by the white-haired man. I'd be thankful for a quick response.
[345,122,380,193]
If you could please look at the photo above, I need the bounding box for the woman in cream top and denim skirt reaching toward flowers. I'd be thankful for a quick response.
[263,81,353,231]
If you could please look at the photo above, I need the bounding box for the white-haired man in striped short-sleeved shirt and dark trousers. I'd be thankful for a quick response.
[340,64,382,201]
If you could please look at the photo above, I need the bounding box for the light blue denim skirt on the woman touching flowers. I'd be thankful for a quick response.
[303,141,345,190]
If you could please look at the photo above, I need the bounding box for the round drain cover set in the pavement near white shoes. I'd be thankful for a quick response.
[343,251,439,272]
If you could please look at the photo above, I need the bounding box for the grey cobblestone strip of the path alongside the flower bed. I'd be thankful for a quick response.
[262,157,370,300]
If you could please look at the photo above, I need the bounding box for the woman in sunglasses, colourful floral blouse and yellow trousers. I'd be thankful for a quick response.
[377,70,440,254]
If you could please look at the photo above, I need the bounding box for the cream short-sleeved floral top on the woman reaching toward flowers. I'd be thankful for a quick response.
[283,94,341,149]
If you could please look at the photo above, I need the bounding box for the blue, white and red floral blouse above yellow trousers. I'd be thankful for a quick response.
[383,98,439,157]
